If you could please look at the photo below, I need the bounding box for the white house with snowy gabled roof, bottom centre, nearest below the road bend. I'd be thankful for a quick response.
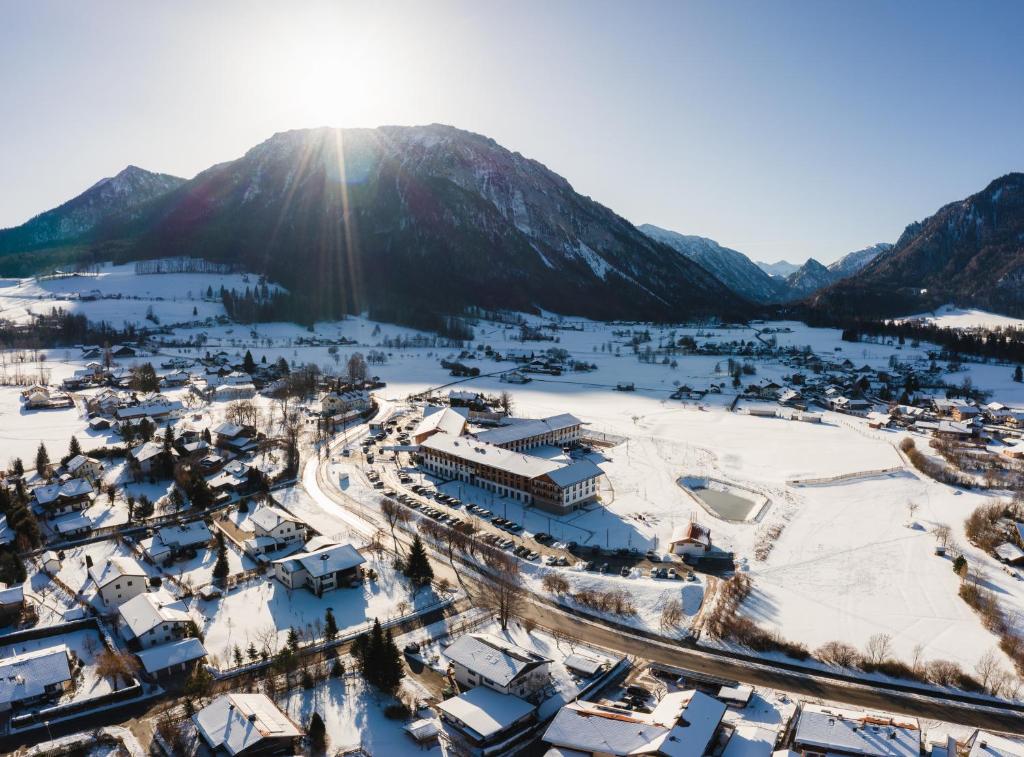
[444,633,551,699]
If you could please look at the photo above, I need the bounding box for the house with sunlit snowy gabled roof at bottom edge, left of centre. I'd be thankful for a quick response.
[193,692,304,757]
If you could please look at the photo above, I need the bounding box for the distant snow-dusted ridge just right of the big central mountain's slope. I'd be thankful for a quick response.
[637,223,787,302]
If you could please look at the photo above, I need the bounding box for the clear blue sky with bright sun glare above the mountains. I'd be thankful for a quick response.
[0,0,1024,262]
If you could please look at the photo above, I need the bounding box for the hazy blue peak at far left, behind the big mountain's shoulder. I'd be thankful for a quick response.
[0,166,185,253]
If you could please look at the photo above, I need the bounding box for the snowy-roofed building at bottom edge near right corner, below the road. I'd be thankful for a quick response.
[793,705,921,757]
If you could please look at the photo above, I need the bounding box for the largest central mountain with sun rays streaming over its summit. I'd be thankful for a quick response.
[6,125,751,322]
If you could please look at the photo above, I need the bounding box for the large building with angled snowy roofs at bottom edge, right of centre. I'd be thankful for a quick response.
[544,690,726,757]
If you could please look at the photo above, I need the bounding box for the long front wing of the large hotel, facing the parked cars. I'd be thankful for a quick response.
[420,433,603,513]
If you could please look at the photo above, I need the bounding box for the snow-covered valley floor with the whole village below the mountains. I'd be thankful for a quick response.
[0,264,1024,757]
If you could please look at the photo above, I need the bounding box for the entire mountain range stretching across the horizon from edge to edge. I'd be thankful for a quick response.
[0,124,1024,322]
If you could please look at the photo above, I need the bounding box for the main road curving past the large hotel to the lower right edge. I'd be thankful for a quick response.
[303,407,1024,733]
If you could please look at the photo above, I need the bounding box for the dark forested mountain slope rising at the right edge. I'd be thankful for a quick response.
[807,173,1024,321]
